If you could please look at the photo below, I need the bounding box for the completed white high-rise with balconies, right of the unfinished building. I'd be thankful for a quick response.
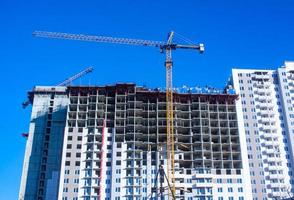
[231,62,294,200]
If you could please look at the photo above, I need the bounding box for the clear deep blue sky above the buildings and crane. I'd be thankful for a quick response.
[0,0,294,200]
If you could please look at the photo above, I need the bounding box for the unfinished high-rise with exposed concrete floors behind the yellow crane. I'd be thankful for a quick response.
[19,84,252,200]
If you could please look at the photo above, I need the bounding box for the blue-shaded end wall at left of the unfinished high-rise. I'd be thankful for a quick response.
[19,87,69,200]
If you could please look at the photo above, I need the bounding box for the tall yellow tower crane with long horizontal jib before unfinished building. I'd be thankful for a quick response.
[33,31,204,197]
